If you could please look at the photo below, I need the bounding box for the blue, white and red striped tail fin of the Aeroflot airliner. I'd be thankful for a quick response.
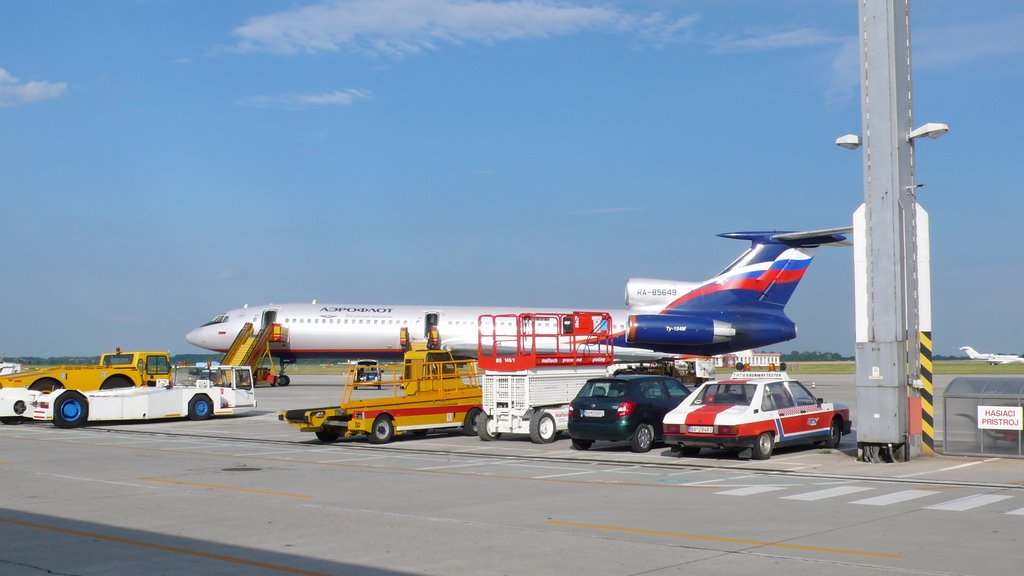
[665,228,851,313]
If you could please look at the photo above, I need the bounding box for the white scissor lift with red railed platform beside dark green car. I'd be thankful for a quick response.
[476,312,614,444]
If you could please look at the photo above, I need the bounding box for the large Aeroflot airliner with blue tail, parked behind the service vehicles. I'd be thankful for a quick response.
[185,228,851,382]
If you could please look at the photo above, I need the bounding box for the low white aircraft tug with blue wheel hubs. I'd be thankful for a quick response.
[32,366,256,428]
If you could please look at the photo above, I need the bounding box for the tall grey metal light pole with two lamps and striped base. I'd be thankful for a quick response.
[836,0,949,462]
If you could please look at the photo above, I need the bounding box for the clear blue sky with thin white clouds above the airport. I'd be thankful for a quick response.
[0,0,1024,356]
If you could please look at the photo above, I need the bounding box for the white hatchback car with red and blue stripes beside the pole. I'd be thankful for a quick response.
[663,372,851,460]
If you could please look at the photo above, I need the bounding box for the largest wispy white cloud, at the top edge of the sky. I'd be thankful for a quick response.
[233,0,696,57]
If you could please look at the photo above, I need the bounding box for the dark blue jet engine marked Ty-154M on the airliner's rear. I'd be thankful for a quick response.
[626,314,736,345]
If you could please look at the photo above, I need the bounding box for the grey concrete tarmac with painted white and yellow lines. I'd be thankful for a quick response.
[0,376,1024,576]
